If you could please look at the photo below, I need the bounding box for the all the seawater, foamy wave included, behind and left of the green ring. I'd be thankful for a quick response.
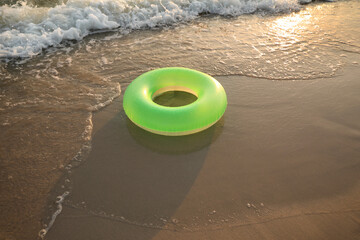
[0,0,360,239]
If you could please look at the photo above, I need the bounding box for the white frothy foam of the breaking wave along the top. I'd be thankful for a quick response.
[0,0,300,58]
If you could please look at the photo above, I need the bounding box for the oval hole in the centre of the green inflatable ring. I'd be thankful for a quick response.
[152,87,198,107]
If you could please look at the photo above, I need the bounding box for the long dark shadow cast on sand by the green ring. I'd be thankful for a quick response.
[47,110,224,240]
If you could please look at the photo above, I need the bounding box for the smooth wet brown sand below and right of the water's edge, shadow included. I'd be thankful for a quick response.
[46,67,360,240]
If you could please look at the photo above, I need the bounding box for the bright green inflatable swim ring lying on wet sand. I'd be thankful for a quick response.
[123,67,227,136]
